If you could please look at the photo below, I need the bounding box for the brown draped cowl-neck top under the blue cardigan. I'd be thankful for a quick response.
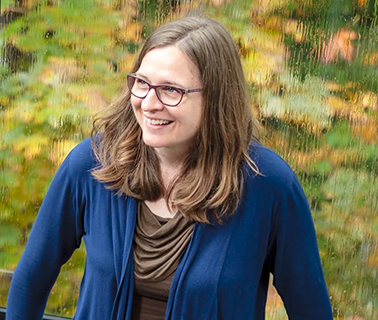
[131,201,194,320]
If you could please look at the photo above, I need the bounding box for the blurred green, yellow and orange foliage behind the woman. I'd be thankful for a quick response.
[0,0,378,320]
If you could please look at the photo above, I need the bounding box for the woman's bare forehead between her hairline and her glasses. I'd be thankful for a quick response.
[136,46,201,86]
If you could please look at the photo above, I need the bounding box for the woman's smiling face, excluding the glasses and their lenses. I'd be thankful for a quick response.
[131,46,203,157]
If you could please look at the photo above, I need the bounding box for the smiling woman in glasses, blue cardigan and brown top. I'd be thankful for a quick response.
[7,18,332,320]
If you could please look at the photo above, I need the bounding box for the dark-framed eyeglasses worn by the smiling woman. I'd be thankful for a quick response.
[127,74,203,107]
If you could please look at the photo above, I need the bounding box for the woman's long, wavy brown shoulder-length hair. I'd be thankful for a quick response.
[92,17,258,222]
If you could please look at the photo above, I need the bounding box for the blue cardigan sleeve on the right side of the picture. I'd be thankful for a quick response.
[270,172,333,320]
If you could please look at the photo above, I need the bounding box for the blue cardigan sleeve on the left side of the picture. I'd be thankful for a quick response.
[6,148,84,320]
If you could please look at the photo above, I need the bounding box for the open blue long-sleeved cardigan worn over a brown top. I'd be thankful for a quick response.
[6,139,332,320]
